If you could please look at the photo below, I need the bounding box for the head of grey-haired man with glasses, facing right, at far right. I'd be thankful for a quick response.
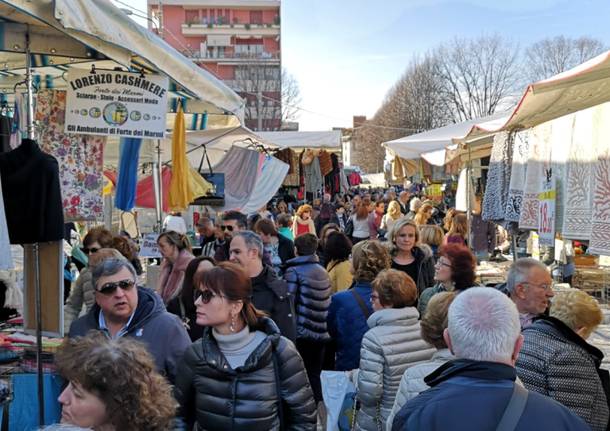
[506,258,555,329]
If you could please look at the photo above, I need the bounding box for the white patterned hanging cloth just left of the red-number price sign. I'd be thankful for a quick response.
[519,122,552,229]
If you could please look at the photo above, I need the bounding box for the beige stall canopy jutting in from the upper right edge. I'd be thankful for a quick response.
[464,51,610,142]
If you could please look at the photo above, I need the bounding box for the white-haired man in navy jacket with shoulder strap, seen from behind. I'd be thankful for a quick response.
[392,287,590,431]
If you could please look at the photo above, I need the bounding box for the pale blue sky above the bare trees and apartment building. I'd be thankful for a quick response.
[119,0,610,130]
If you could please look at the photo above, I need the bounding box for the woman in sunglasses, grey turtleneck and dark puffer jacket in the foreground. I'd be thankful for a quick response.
[176,262,316,431]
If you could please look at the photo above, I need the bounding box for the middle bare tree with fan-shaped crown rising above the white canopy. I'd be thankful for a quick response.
[435,35,519,121]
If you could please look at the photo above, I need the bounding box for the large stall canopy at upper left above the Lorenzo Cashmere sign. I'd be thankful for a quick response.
[0,0,244,122]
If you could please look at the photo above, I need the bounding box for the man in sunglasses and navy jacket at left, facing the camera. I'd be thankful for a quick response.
[69,258,191,383]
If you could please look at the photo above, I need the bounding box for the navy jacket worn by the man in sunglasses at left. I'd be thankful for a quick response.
[69,287,191,382]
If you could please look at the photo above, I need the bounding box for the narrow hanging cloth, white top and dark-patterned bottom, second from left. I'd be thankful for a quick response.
[504,130,529,222]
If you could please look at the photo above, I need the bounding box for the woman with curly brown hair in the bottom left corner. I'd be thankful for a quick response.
[55,331,178,431]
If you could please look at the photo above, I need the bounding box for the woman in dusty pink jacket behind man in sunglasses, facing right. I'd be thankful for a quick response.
[157,231,195,305]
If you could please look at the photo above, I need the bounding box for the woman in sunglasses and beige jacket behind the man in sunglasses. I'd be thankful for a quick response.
[64,226,115,331]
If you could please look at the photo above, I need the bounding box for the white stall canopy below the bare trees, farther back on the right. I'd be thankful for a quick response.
[382,112,507,166]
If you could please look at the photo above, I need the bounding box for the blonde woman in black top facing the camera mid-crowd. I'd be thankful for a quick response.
[389,218,434,296]
